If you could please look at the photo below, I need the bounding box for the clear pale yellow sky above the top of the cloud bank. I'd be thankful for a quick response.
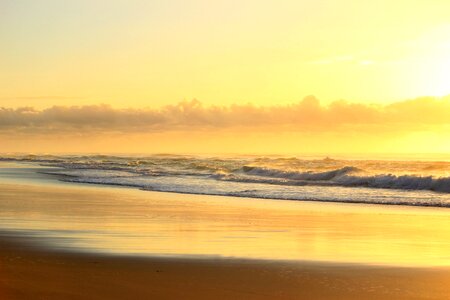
[0,0,450,107]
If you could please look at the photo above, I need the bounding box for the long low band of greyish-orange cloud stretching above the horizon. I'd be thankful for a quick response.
[0,96,450,134]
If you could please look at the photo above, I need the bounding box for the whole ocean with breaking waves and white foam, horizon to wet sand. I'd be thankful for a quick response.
[0,154,450,207]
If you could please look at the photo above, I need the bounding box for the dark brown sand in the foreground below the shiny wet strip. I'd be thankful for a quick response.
[0,237,450,300]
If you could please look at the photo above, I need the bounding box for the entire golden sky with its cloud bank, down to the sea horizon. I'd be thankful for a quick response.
[0,0,450,153]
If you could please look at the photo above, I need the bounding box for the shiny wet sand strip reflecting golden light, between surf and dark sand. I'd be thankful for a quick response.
[0,185,450,266]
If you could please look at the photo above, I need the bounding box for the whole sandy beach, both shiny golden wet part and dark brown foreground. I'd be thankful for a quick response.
[0,166,450,300]
